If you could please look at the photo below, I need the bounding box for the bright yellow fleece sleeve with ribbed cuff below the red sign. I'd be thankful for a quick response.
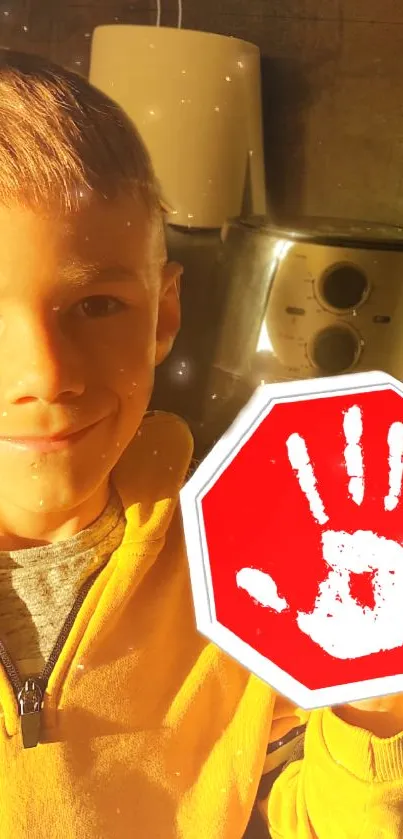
[259,708,403,839]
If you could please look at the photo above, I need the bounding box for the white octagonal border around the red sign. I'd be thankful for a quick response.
[180,371,403,710]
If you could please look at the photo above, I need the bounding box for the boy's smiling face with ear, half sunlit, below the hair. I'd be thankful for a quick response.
[0,198,181,531]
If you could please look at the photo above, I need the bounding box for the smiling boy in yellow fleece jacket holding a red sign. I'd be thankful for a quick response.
[0,51,399,839]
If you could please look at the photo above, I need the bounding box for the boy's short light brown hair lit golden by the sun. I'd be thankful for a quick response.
[0,49,164,218]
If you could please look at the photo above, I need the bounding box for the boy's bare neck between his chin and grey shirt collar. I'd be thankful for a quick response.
[0,482,110,551]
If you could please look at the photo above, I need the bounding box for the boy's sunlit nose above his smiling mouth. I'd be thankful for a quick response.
[0,319,85,404]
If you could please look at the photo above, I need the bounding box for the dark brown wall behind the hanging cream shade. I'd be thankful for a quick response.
[4,0,403,223]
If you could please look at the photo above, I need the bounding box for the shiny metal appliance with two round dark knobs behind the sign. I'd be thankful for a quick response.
[188,217,403,450]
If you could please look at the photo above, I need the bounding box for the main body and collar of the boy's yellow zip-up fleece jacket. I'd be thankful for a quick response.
[0,414,303,839]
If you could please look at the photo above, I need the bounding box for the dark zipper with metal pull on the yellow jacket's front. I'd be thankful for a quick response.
[0,566,104,749]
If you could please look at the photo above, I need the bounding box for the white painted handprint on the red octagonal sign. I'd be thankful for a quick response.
[236,405,403,659]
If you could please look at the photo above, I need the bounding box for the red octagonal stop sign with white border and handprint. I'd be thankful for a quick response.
[181,372,403,709]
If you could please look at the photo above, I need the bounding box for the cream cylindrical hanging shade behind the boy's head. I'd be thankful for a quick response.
[90,25,266,228]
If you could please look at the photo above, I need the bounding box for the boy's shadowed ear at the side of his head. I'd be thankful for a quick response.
[155,262,183,366]
